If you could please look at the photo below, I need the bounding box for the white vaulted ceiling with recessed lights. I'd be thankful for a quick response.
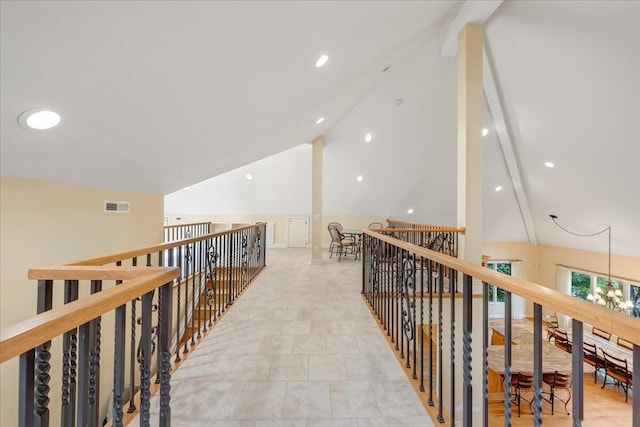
[0,1,640,256]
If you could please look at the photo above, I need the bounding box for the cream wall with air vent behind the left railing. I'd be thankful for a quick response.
[0,177,164,426]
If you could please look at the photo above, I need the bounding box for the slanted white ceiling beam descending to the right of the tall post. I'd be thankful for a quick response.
[482,49,537,245]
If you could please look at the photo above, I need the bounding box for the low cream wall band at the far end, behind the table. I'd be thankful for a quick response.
[166,214,387,248]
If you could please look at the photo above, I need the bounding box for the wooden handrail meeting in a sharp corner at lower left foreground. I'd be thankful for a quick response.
[0,267,180,363]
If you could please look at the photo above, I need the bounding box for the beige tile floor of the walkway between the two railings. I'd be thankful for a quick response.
[138,249,433,427]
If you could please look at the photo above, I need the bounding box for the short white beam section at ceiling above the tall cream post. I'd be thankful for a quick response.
[440,0,503,58]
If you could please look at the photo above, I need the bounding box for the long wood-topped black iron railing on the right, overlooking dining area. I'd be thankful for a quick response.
[362,230,640,426]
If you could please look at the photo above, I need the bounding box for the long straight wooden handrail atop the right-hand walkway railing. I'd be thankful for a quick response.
[363,229,640,345]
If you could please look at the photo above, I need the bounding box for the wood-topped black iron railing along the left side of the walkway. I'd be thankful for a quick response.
[0,223,266,426]
